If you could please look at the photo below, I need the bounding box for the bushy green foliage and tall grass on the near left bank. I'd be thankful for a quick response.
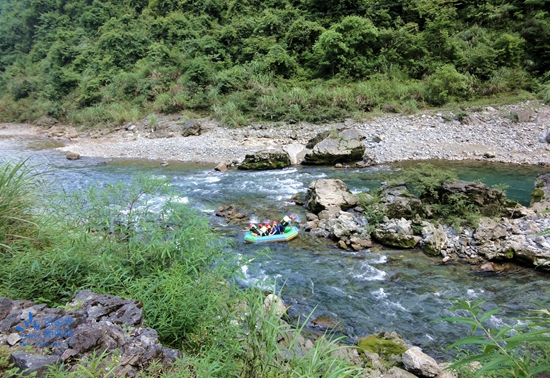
[0,163,357,378]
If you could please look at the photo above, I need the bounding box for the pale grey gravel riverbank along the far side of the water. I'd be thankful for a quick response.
[4,101,550,165]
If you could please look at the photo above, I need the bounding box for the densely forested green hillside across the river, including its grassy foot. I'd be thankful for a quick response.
[0,0,550,126]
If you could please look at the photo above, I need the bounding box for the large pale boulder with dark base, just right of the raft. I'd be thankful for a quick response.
[306,179,357,214]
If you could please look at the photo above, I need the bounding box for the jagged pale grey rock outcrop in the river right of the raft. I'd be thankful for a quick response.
[302,174,550,271]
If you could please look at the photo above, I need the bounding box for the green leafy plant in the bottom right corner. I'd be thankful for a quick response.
[439,300,550,378]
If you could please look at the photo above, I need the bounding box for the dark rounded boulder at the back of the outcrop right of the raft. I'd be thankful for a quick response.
[432,180,505,217]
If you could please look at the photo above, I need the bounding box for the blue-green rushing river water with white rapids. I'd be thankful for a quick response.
[0,137,550,360]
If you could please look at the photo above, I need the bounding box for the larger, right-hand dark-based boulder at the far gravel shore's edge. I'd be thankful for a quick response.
[302,129,365,165]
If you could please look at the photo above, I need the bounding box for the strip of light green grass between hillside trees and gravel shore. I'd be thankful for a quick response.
[0,72,550,128]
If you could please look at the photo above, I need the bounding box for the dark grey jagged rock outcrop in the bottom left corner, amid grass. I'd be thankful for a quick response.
[0,290,181,376]
